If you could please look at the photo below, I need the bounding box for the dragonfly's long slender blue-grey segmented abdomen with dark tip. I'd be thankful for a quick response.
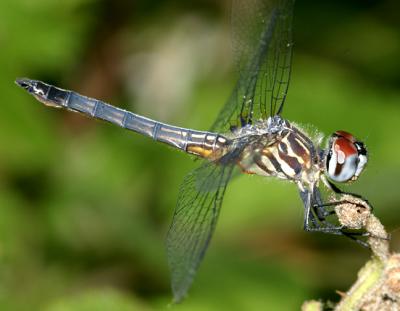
[17,79,228,160]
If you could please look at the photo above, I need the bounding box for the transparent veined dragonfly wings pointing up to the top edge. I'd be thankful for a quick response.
[211,0,294,132]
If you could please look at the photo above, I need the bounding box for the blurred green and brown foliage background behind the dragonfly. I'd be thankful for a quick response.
[0,0,400,311]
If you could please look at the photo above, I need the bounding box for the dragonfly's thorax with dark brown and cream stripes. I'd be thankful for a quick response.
[239,116,321,184]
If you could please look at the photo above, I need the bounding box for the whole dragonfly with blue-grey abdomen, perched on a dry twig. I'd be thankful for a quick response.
[16,0,368,302]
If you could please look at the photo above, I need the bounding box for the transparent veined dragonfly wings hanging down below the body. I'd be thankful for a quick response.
[167,162,233,302]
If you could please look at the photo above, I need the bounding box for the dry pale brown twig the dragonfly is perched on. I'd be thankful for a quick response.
[302,194,400,311]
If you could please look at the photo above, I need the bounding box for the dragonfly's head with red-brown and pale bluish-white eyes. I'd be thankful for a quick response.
[326,131,368,182]
